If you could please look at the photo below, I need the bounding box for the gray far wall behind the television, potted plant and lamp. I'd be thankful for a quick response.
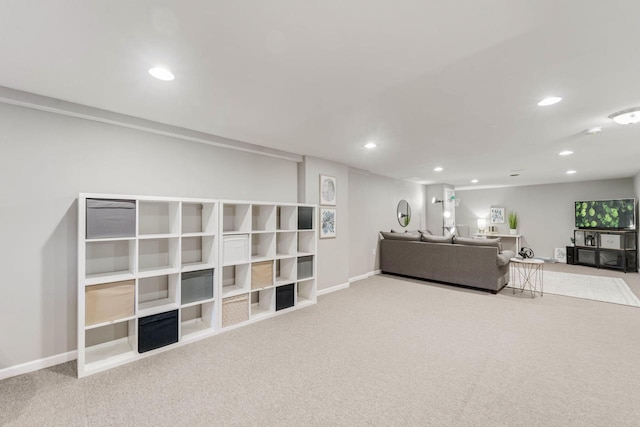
[456,178,637,257]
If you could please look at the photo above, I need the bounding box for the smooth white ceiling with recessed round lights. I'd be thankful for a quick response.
[0,0,640,188]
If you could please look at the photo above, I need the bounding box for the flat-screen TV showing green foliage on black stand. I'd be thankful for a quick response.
[576,199,636,230]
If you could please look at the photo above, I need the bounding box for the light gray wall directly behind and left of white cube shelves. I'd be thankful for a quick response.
[0,104,298,369]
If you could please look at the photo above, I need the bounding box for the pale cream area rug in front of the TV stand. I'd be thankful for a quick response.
[510,271,640,307]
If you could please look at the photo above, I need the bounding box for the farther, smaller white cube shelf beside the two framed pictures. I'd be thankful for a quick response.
[220,200,317,329]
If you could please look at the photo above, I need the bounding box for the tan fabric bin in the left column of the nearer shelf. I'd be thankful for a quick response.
[84,280,135,326]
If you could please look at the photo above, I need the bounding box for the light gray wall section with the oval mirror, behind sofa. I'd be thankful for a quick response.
[349,169,425,278]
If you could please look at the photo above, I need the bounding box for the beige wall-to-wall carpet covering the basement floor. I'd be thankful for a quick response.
[0,266,640,426]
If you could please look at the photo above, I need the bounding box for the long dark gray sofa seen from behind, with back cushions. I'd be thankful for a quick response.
[380,233,515,294]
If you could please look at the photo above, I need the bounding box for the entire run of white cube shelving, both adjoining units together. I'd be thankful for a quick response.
[78,194,317,377]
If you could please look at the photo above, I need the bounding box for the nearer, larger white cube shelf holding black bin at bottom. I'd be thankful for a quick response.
[78,194,220,377]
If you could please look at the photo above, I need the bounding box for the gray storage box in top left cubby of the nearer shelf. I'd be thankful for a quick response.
[87,199,136,239]
